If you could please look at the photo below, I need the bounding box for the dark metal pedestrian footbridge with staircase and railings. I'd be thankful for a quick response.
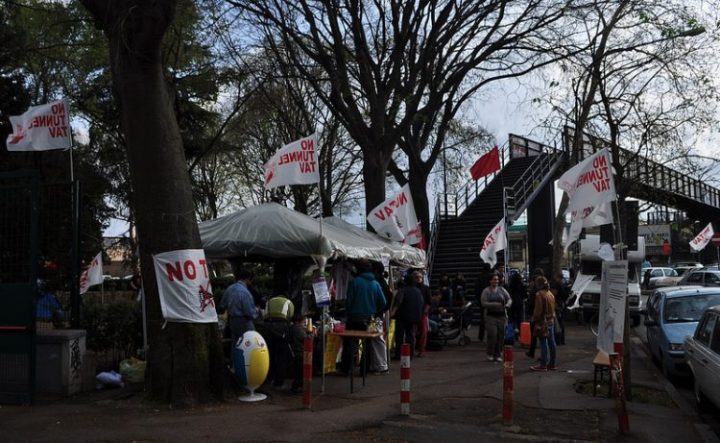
[428,128,720,293]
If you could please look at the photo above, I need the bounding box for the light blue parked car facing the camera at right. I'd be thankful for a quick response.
[645,286,720,377]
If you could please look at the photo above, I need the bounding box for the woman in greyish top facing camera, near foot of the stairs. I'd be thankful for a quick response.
[480,273,512,361]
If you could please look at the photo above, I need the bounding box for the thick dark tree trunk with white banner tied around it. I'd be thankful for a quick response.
[83,0,223,406]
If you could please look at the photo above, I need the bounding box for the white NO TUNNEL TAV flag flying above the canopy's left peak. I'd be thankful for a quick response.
[264,134,320,189]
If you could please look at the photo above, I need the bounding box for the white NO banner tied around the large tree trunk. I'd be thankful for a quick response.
[153,249,217,323]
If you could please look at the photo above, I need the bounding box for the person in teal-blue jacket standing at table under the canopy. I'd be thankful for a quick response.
[340,260,387,372]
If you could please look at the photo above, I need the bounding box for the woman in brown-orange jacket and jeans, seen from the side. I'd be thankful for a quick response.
[530,277,557,371]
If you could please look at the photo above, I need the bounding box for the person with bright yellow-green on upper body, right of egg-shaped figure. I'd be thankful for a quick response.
[264,295,295,387]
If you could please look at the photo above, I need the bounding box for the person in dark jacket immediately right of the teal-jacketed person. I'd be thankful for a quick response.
[391,271,425,360]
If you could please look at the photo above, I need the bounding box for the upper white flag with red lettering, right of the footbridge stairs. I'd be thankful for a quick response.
[558,148,617,211]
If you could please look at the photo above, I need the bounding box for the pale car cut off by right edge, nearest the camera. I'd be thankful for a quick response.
[685,306,720,409]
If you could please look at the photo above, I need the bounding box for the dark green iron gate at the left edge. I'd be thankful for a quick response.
[0,171,39,404]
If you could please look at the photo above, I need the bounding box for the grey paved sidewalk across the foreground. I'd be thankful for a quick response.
[0,324,717,443]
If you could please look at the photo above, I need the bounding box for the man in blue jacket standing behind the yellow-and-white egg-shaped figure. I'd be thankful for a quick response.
[220,269,257,346]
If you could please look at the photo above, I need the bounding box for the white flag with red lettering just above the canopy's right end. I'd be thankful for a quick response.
[367,184,422,245]
